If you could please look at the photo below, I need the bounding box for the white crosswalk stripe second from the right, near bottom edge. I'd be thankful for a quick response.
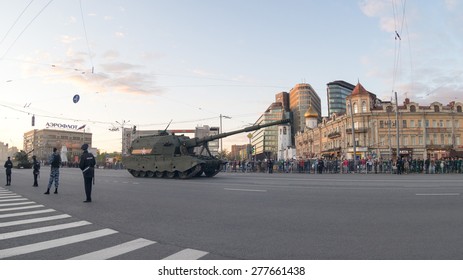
[70,238,156,260]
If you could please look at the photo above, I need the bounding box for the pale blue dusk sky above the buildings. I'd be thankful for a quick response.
[0,0,463,152]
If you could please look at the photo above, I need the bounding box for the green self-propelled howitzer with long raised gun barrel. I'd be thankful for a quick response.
[122,119,290,179]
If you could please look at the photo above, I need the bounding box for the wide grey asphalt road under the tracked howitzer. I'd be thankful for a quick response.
[0,167,463,260]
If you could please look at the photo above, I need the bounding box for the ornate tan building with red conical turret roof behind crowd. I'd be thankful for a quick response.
[295,83,463,159]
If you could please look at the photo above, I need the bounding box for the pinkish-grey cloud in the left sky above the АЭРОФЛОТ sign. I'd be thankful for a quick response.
[24,48,162,95]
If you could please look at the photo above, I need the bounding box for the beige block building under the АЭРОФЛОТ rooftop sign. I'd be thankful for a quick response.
[23,129,92,162]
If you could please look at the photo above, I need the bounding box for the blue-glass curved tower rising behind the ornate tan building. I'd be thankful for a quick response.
[326,81,355,116]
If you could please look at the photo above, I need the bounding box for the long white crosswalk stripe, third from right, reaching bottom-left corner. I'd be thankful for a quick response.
[0,228,117,259]
